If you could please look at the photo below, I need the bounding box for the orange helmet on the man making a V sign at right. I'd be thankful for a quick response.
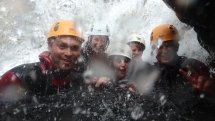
[150,24,180,44]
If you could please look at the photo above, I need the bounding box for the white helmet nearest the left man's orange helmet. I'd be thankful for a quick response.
[89,22,110,36]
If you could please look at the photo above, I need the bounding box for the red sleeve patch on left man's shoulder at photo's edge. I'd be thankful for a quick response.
[0,71,20,92]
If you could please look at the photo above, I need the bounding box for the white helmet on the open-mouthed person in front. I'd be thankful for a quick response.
[108,43,132,59]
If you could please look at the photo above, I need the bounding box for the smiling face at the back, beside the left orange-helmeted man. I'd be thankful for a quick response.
[91,35,108,53]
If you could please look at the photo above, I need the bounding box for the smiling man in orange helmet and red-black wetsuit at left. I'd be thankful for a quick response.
[0,20,84,96]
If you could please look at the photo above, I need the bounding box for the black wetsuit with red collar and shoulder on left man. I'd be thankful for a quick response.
[0,51,83,95]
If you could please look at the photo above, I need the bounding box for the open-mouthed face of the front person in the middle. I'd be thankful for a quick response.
[112,56,130,79]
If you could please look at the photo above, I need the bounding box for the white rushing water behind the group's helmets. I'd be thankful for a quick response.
[0,0,208,75]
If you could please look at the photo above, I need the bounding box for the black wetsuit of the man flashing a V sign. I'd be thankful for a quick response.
[152,57,215,121]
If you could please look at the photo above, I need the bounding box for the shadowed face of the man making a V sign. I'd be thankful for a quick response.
[156,41,179,65]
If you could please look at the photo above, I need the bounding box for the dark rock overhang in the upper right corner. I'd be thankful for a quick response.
[163,0,215,68]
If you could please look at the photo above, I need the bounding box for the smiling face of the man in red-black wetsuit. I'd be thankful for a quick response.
[48,36,81,71]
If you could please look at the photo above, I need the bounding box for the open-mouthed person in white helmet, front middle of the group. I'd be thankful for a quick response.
[92,43,132,87]
